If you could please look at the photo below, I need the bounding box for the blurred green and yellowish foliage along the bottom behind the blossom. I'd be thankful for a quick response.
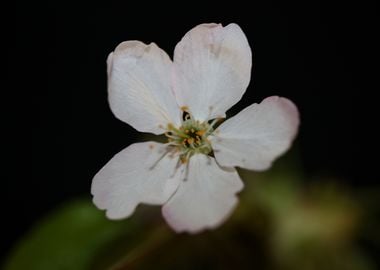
[5,154,379,270]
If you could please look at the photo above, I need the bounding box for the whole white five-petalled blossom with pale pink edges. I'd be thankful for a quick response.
[91,24,299,233]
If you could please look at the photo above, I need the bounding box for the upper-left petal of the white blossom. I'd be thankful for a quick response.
[107,41,182,134]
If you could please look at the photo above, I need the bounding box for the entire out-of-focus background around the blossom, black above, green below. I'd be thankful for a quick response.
[4,1,380,270]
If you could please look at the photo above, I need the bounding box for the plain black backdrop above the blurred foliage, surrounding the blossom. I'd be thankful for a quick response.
[1,1,375,262]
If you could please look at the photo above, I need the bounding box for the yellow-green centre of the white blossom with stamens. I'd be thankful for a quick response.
[165,113,219,163]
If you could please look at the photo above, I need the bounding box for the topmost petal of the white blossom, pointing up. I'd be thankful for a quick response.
[174,24,252,120]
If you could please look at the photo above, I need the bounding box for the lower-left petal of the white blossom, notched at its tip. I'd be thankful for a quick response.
[91,142,180,219]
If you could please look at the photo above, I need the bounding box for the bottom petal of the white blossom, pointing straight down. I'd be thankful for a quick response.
[162,154,243,233]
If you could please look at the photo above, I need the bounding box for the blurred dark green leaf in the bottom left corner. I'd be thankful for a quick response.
[4,199,135,270]
